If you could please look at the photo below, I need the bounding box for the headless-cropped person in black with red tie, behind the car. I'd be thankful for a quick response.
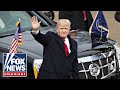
[58,11,93,31]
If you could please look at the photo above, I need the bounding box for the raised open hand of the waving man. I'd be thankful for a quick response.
[30,16,41,31]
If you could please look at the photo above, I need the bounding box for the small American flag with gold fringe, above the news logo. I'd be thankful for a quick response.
[9,19,22,53]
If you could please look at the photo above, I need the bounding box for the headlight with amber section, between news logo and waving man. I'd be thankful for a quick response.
[33,59,43,79]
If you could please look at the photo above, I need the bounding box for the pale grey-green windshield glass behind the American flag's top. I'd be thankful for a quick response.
[0,11,31,33]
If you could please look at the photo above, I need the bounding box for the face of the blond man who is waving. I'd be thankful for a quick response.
[57,23,70,38]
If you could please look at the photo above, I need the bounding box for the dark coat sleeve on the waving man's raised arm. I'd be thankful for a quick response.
[31,31,50,46]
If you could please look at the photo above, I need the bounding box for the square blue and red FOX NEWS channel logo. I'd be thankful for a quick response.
[3,53,27,77]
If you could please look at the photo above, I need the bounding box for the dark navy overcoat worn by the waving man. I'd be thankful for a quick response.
[32,31,79,79]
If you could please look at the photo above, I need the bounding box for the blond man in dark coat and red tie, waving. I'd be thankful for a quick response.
[31,16,79,79]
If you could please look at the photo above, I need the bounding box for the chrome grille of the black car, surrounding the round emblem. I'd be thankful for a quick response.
[78,51,117,79]
